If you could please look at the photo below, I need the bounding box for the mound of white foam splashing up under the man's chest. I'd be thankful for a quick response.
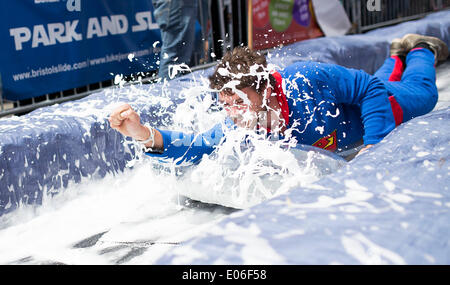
[176,130,326,208]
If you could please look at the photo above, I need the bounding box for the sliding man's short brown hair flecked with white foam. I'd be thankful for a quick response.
[209,46,276,95]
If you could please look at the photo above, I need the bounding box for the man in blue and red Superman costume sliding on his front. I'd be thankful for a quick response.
[109,34,448,162]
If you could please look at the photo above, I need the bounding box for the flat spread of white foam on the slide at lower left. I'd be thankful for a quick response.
[0,163,232,264]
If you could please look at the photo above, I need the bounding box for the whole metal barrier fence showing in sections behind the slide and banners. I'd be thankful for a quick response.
[0,0,450,118]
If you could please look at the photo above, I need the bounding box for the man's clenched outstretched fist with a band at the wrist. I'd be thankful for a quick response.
[108,104,163,149]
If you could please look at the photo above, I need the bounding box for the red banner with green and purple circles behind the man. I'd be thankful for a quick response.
[248,0,323,50]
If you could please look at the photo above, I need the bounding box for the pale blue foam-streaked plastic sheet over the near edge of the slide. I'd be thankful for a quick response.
[158,108,450,264]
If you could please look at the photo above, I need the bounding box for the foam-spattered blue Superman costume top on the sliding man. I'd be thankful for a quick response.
[147,62,395,163]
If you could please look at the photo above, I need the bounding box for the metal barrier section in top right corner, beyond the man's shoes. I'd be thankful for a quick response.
[341,0,450,33]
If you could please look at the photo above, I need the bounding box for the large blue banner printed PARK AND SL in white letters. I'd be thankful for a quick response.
[0,0,161,100]
